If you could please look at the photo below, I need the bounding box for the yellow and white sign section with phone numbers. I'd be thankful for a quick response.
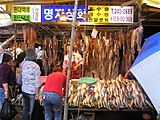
[88,6,134,24]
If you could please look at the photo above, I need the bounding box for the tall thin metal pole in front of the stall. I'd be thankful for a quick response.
[63,0,78,120]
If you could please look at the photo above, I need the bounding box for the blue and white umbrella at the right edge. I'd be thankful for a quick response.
[131,32,160,114]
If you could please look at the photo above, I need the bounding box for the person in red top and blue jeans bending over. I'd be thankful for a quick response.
[43,64,67,120]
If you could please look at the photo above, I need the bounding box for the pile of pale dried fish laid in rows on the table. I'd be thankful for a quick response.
[68,75,151,110]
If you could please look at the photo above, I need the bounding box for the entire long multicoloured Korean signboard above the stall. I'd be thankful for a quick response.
[11,5,134,24]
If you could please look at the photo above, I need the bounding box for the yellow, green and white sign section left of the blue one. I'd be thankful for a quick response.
[11,5,41,22]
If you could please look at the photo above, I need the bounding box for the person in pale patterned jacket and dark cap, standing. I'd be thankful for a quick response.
[21,48,41,120]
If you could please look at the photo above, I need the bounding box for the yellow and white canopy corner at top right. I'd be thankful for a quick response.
[143,0,160,8]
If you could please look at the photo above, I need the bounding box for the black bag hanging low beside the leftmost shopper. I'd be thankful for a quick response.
[0,99,14,120]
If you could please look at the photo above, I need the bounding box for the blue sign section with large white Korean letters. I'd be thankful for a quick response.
[41,5,88,22]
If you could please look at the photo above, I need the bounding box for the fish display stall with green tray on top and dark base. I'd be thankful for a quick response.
[68,75,156,120]
